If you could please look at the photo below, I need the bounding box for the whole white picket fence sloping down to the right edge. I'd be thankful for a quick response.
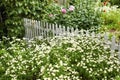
[24,18,120,62]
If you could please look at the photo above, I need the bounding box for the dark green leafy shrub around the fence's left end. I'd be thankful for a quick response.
[0,0,48,37]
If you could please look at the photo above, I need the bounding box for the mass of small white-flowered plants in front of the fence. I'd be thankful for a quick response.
[0,35,120,80]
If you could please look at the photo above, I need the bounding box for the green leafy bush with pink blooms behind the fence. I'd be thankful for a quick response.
[45,0,101,29]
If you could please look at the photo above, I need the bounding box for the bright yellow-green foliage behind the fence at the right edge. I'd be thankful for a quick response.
[100,8,120,41]
